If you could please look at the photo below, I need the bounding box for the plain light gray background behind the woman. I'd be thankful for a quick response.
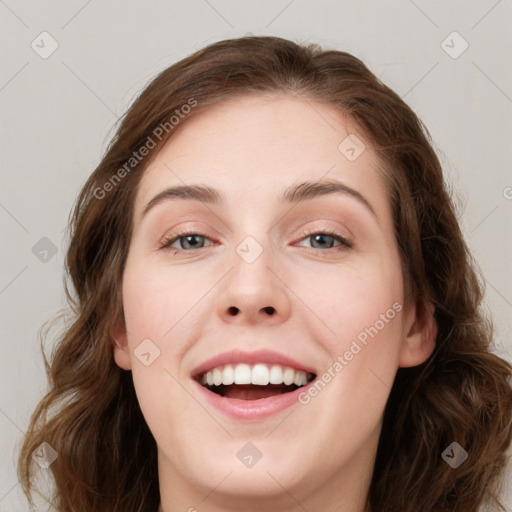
[0,0,512,511]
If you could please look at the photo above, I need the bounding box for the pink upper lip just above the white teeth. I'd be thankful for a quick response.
[191,350,316,378]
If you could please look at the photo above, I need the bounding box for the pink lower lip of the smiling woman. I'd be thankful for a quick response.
[192,379,314,420]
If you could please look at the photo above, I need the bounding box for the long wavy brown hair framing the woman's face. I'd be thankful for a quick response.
[18,37,512,512]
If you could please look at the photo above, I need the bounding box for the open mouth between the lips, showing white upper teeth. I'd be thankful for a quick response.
[196,364,316,400]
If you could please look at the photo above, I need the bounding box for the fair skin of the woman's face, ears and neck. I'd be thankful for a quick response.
[114,94,434,512]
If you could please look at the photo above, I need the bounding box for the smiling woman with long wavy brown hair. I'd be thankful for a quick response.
[19,37,512,512]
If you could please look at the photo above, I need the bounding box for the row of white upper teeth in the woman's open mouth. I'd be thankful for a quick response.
[201,363,308,387]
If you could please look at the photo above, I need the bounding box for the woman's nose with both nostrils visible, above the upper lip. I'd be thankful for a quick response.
[217,243,291,325]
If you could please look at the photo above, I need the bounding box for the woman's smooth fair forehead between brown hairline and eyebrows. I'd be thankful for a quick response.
[135,94,387,222]
